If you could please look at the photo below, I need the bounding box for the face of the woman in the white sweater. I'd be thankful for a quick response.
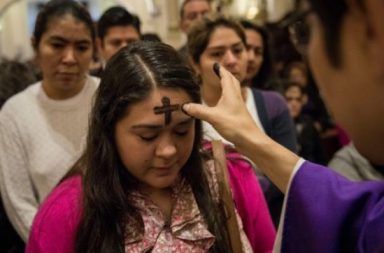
[36,14,93,99]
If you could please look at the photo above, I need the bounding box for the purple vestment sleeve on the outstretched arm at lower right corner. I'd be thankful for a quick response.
[281,162,384,253]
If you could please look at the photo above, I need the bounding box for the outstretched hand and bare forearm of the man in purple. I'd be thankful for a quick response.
[183,63,299,192]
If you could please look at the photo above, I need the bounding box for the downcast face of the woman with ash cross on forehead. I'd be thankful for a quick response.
[115,88,195,192]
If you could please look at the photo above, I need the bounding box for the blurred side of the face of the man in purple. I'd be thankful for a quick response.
[308,1,384,163]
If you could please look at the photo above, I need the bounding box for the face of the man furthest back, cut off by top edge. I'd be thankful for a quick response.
[180,0,211,33]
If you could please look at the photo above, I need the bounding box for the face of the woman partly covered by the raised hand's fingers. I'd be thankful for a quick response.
[196,26,247,87]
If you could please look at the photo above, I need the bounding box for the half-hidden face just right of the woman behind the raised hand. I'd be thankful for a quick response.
[245,29,264,80]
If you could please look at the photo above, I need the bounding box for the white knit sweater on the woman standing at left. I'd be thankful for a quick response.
[0,77,99,241]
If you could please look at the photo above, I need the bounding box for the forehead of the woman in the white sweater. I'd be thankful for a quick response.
[43,14,92,41]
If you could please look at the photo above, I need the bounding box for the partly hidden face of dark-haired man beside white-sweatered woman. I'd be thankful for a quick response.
[97,25,140,62]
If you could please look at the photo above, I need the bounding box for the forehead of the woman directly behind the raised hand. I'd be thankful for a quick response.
[207,26,242,48]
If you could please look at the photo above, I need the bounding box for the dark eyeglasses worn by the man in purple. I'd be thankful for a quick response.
[281,9,312,54]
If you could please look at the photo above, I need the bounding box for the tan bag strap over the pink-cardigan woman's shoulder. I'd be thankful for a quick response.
[212,140,243,253]
